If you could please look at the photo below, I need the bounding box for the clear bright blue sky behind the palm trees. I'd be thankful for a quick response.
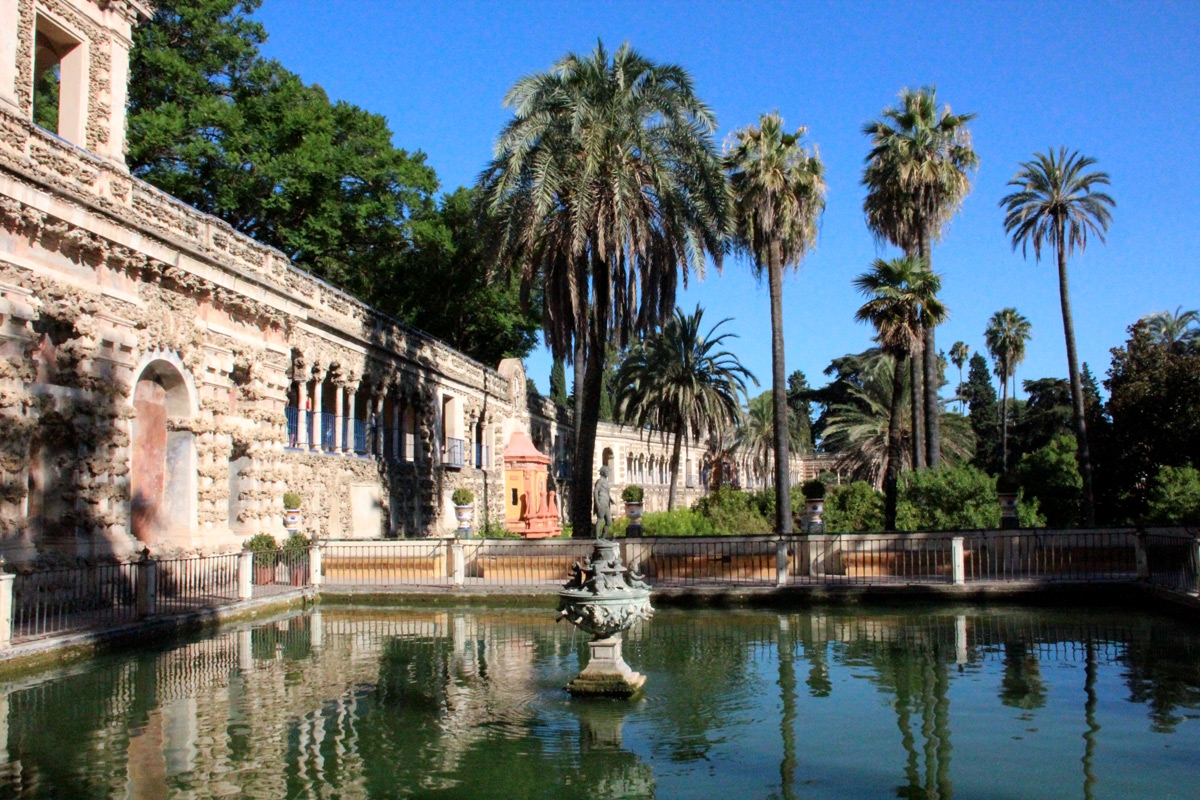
[257,0,1200,400]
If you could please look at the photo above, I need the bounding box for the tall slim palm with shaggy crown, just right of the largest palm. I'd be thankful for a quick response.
[725,114,826,534]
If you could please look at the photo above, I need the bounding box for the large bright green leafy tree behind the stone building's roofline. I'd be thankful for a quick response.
[127,0,437,299]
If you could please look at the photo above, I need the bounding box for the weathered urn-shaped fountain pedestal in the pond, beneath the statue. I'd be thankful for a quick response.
[558,539,654,697]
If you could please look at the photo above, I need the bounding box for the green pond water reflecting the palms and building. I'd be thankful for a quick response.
[0,607,1200,800]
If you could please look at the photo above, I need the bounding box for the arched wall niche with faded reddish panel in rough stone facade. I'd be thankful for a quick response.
[130,350,198,547]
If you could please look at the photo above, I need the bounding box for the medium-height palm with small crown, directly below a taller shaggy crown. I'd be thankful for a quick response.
[854,257,948,530]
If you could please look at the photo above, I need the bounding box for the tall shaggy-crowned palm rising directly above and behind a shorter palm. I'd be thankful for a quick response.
[863,86,979,467]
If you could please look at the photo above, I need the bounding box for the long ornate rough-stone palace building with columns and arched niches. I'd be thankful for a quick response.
[0,0,830,558]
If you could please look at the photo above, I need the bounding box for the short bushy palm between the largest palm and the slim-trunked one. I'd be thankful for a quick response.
[616,306,758,511]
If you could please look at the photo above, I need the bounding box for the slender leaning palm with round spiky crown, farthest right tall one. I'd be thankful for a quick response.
[1000,148,1116,525]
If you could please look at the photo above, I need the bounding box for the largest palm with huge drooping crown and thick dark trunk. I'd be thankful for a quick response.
[480,43,730,535]
